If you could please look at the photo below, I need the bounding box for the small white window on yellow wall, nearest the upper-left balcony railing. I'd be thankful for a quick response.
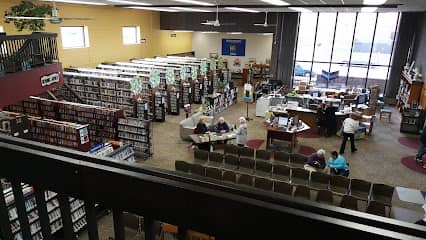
[61,26,89,48]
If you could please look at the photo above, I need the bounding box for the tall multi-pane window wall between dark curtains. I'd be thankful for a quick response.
[293,12,399,92]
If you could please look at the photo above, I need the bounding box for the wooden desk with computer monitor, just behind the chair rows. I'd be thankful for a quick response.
[266,121,310,149]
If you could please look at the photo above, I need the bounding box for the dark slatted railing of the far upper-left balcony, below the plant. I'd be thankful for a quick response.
[0,33,58,74]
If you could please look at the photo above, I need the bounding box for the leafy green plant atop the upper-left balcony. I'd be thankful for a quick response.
[4,0,52,32]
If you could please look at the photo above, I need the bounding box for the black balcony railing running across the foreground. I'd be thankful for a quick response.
[0,135,426,240]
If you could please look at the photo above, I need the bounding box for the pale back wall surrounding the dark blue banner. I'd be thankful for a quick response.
[192,32,273,71]
